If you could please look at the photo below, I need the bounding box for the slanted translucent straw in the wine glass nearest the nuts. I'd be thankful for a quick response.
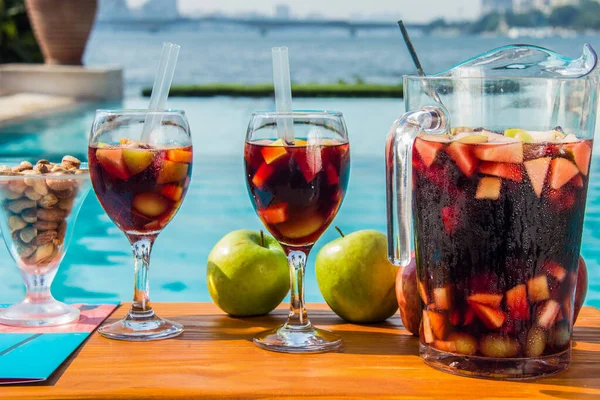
[141,42,181,143]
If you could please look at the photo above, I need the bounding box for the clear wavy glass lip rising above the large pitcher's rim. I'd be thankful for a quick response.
[435,44,597,78]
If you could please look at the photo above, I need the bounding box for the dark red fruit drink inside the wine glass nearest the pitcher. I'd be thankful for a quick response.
[244,139,350,246]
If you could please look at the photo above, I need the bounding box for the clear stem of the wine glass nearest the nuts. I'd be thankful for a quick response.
[129,238,154,318]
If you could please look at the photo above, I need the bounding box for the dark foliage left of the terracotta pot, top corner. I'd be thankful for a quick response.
[0,0,43,63]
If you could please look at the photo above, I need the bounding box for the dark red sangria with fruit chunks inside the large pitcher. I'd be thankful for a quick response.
[413,129,592,358]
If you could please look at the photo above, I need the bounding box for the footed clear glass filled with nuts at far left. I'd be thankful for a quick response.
[0,161,90,327]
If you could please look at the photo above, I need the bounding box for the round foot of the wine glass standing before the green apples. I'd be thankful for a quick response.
[253,325,342,353]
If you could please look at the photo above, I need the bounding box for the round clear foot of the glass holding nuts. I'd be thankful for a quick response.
[0,299,80,327]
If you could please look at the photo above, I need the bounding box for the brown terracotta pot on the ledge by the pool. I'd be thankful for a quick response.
[25,0,97,65]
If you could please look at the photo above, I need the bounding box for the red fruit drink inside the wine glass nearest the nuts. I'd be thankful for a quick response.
[88,140,192,234]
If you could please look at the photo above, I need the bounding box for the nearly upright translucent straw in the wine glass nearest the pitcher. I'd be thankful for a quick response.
[271,47,294,144]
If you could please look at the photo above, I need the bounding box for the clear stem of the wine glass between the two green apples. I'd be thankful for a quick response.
[284,249,310,329]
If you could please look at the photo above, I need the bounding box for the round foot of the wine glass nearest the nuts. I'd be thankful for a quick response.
[98,313,183,342]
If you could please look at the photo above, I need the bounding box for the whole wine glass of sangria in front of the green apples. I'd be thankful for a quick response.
[244,111,350,353]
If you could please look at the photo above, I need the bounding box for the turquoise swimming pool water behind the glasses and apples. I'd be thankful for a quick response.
[0,98,600,306]
